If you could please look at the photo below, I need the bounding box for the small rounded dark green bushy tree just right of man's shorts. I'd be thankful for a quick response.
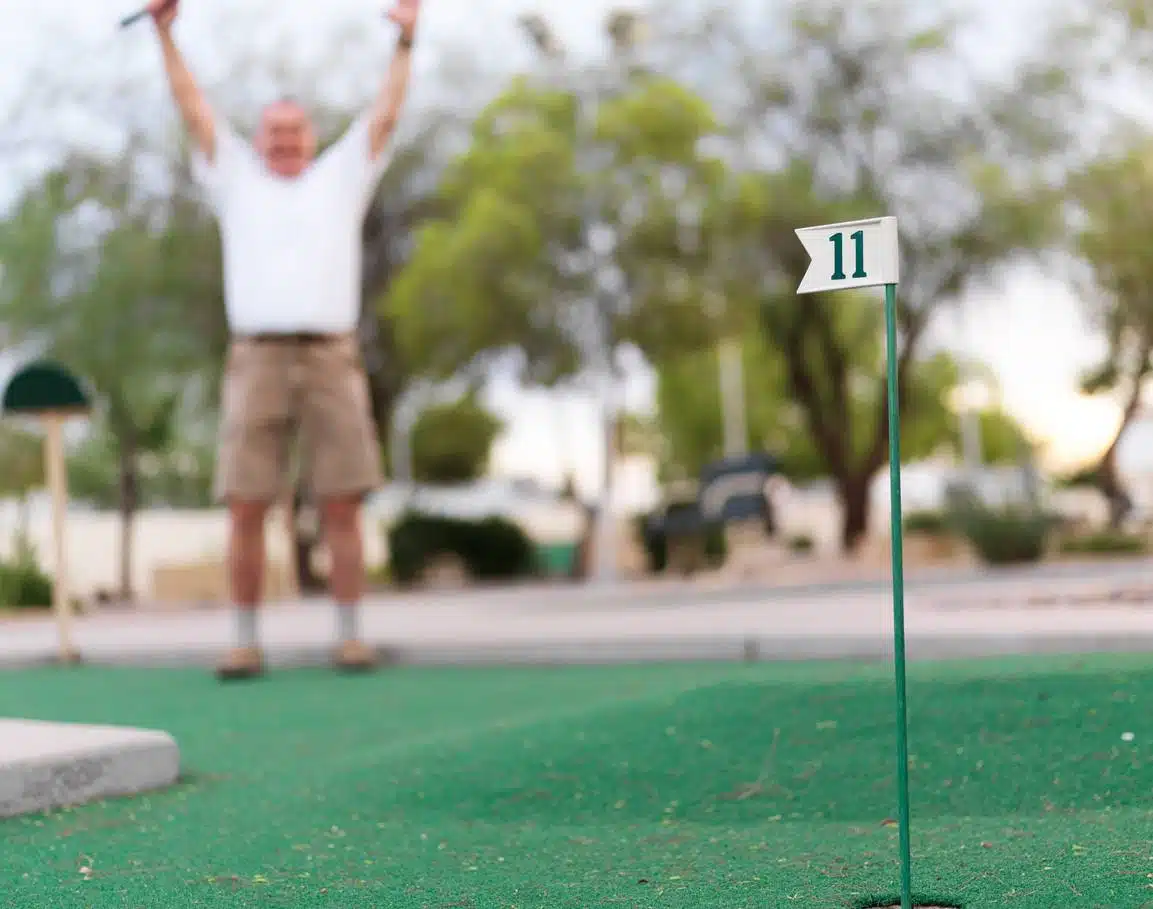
[412,391,504,486]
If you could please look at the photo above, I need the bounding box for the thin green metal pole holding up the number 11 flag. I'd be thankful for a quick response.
[884,284,913,909]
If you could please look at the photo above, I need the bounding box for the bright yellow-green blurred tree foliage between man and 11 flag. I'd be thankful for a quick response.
[385,73,716,385]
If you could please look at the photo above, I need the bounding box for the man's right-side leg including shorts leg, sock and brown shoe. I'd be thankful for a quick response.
[302,337,380,670]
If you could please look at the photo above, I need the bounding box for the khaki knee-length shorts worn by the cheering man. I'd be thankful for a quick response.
[216,335,382,502]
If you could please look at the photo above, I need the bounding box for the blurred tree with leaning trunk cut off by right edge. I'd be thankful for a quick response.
[1071,147,1153,527]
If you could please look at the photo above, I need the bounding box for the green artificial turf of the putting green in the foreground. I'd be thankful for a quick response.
[0,656,1153,909]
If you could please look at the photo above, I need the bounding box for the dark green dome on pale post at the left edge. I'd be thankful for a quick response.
[0,361,91,663]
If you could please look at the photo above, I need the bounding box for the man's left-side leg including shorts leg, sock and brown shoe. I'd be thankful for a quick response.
[217,341,292,679]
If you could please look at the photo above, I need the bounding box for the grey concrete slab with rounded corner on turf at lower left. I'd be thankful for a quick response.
[0,720,180,818]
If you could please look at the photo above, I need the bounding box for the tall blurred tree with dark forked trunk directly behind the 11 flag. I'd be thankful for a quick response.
[650,0,1078,550]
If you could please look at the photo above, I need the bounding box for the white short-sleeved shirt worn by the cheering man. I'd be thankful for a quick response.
[193,115,389,335]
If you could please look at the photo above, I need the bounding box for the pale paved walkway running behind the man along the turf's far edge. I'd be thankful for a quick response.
[0,568,1153,667]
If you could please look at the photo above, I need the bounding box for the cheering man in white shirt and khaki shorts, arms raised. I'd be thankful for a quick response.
[149,0,419,679]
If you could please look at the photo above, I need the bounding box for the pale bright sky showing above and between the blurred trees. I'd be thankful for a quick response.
[0,0,1134,507]
